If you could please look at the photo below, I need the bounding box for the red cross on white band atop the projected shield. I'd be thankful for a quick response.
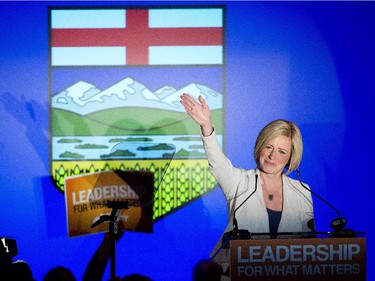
[50,8,223,66]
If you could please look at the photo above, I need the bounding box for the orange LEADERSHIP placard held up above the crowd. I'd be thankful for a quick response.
[65,168,154,237]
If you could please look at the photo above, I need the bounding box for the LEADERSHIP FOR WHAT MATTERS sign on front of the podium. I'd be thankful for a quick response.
[230,238,366,281]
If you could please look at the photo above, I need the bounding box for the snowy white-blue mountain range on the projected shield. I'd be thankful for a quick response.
[52,77,223,116]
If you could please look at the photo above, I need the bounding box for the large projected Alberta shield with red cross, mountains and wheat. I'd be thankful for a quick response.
[49,6,225,219]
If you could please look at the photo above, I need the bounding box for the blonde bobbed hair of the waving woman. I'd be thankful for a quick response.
[254,119,303,174]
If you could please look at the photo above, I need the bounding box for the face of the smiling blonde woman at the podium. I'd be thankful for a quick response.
[259,136,292,174]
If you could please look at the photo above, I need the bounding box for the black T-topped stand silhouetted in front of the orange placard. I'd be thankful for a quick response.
[91,201,130,281]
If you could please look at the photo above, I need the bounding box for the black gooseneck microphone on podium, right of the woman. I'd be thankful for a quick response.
[296,168,355,237]
